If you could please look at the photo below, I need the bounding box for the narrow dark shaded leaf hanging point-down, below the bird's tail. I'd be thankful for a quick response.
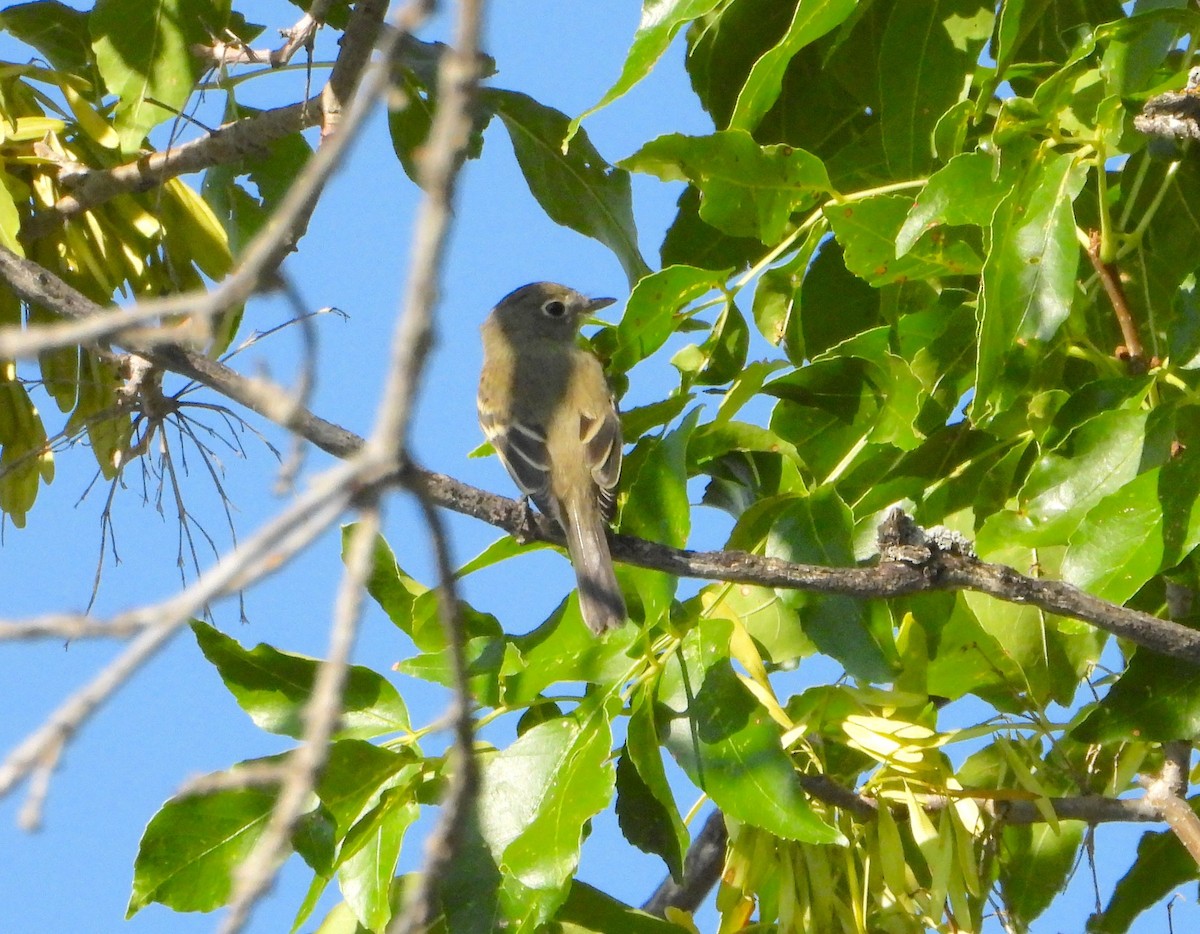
[617,690,690,885]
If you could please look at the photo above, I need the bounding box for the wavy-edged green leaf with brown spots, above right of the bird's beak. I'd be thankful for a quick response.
[619,130,830,244]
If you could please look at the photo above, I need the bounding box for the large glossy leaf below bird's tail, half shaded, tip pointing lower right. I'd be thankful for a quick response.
[655,619,845,843]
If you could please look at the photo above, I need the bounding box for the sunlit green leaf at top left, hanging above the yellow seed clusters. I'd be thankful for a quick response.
[88,0,220,152]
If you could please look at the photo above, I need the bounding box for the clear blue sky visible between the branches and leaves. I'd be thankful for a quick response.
[0,0,1182,934]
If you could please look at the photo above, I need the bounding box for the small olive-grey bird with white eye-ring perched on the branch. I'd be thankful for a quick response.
[478,282,625,635]
